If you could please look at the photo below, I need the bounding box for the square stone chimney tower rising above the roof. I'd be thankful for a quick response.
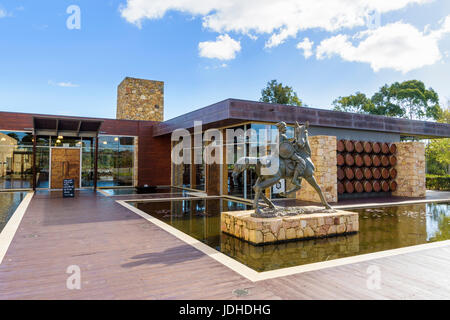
[116,77,164,121]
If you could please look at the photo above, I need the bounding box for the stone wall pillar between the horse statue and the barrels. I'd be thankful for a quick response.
[297,136,338,202]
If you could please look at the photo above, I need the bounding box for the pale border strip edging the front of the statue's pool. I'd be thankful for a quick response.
[116,200,450,282]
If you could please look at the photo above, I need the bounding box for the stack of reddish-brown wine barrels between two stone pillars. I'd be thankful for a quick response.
[337,140,397,195]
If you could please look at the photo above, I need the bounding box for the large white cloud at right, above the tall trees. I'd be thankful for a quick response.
[316,16,450,73]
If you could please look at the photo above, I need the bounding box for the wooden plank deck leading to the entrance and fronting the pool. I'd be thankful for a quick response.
[0,192,450,299]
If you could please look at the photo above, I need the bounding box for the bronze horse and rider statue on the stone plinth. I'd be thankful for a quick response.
[232,122,331,215]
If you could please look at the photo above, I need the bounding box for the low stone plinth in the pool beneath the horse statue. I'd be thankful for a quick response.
[221,210,359,245]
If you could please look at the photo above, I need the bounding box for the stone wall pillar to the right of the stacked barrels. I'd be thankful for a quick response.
[392,142,426,198]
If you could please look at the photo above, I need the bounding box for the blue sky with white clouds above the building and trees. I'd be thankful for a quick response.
[0,0,450,119]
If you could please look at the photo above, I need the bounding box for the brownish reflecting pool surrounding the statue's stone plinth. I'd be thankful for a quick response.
[132,199,450,272]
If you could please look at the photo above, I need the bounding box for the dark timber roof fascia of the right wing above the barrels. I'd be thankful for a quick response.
[154,99,450,138]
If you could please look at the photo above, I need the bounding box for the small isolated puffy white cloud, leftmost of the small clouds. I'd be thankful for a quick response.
[198,34,241,60]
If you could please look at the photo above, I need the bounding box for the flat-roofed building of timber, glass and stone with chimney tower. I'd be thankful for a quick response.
[0,78,450,202]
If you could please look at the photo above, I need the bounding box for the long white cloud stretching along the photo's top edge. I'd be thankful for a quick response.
[120,0,432,48]
